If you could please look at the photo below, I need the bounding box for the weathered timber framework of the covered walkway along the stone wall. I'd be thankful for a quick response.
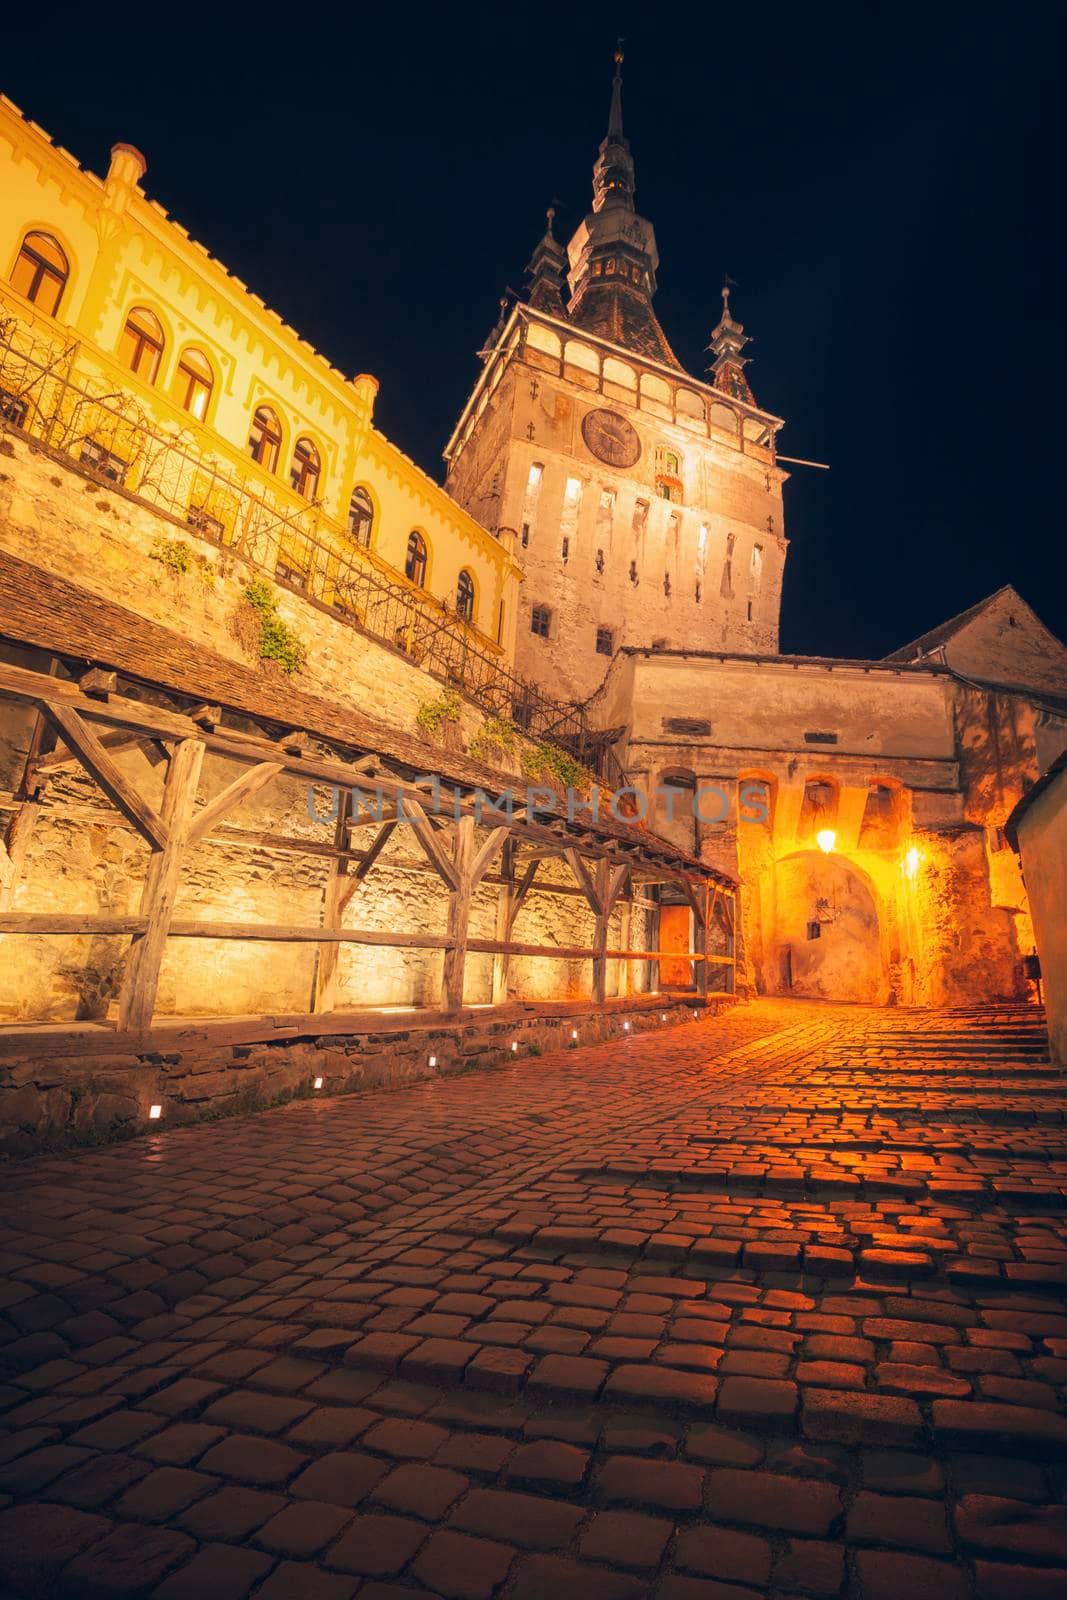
[0,630,736,1037]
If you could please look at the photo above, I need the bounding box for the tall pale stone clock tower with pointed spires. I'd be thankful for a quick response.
[445,51,785,701]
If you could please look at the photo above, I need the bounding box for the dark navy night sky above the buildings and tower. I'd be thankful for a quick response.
[2,0,1067,656]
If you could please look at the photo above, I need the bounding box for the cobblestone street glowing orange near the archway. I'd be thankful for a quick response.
[0,1000,1067,1600]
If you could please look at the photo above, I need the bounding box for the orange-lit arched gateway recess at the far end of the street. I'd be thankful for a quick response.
[768,850,888,1003]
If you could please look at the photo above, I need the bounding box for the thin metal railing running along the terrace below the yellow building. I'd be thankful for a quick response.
[0,306,585,757]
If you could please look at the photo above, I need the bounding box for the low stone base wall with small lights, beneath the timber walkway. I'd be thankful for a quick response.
[0,995,734,1155]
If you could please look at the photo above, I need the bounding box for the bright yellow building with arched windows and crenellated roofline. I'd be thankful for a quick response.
[0,98,520,668]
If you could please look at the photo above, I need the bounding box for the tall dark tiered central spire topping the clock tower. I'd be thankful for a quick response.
[568,48,681,366]
